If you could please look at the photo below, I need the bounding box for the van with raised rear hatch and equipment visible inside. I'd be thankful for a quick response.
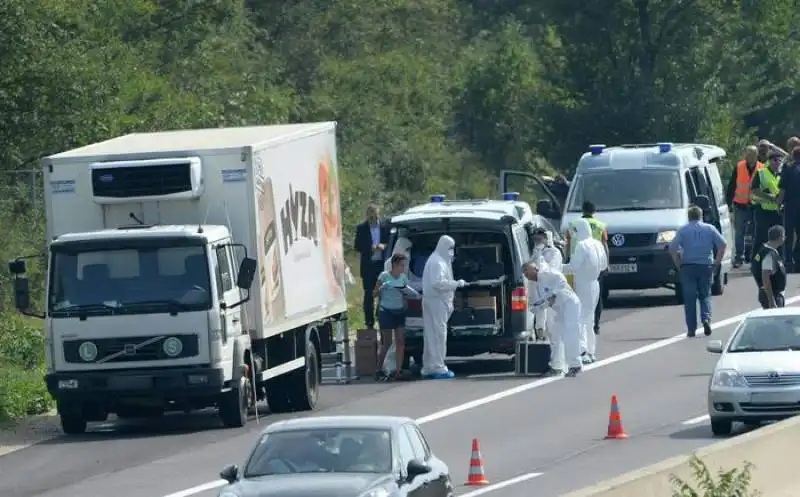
[387,191,563,364]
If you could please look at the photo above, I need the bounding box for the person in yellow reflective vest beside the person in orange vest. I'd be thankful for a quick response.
[751,151,783,253]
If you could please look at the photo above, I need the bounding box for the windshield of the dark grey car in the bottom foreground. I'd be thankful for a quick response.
[244,428,392,478]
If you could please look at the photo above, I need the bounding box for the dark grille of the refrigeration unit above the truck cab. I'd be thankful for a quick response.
[92,162,192,198]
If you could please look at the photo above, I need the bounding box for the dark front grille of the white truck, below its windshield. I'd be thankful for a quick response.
[64,335,198,364]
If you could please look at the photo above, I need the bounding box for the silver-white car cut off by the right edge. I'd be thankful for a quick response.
[706,307,800,435]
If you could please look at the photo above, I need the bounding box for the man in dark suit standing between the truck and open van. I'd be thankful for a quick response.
[354,204,389,329]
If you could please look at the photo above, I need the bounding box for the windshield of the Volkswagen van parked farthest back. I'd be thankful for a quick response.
[568,169,683,212]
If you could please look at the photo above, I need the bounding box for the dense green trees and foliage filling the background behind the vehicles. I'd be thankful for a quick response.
[0,0,800,418]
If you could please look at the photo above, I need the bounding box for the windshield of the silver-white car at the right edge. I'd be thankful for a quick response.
[728,316,800,352]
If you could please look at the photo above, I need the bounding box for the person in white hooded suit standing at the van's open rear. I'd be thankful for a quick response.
[422,235,466,380]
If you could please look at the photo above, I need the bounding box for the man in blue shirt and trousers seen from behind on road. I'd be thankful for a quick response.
[669,205,727,337]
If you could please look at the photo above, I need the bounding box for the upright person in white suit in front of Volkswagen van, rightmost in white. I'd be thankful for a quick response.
[563,218,608,364]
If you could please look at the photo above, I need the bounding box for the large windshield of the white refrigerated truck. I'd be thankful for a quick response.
[48,244,211,317]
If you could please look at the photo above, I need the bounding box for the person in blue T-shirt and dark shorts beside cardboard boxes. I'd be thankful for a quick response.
[373,253,419,377]
